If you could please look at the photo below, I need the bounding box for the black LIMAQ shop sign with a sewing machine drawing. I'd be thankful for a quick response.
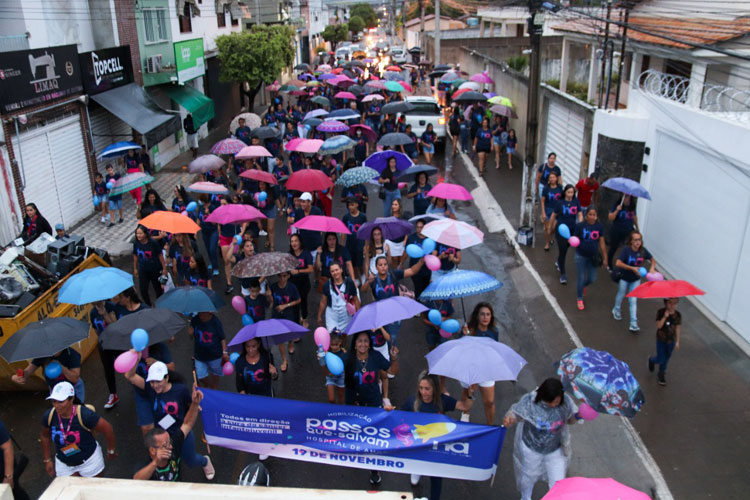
[0,45,83,113]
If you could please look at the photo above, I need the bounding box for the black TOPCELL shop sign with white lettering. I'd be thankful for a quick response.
[78,45,133,95]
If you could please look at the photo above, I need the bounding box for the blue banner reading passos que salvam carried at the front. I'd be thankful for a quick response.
[201,389,505,481]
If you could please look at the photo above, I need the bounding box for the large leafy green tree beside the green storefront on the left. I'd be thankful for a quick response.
[216,24,294,110]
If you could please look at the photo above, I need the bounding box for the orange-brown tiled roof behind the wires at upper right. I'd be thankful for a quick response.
[552,16,750,49]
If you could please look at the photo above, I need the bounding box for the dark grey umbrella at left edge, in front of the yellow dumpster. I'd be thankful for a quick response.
[0,317,91,363]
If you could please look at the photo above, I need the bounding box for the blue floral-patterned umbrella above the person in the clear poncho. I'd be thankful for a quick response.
[557,347,645,418]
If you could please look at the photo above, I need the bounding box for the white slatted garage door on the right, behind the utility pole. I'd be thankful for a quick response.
[540,101,586,185]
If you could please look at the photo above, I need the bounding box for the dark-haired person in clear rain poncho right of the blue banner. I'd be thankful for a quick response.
[503,378,581,500]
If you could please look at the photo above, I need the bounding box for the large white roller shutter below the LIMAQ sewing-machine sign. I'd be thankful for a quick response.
[13,114,94,227]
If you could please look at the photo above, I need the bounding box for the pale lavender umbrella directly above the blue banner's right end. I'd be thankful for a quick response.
[425,336,526,385]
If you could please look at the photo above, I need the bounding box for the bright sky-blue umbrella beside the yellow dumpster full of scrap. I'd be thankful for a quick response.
[57,266,133,306]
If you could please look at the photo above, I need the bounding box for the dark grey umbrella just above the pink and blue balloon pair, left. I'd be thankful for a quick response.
[99,309,188,351]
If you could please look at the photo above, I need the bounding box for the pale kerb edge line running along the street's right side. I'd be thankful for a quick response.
[459,153,674,500]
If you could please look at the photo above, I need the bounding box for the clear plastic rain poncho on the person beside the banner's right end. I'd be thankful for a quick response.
[509,391,578,494]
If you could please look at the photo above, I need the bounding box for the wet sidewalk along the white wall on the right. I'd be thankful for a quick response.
[448,142,750,500]
